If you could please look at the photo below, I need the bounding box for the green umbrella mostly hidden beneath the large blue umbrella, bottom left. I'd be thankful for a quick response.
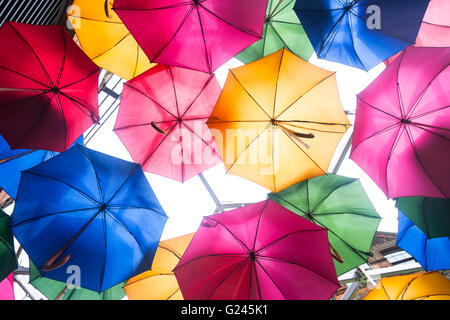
[30,261,126,300]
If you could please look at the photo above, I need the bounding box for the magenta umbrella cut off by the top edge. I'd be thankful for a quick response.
[113,0,268,73]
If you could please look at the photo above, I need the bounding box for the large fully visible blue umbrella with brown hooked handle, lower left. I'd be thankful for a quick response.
[11,145,167,292]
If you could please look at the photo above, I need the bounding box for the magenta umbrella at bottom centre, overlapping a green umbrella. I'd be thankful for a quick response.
[174,199,339,300]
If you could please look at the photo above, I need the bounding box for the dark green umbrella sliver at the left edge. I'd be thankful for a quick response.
[0,210,17,282]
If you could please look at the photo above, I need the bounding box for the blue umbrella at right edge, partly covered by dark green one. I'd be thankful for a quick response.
[397,211,450,271]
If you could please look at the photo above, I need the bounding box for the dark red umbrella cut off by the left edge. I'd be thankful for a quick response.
[0,22,99,152]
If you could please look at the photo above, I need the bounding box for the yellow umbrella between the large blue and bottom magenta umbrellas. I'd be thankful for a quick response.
[124,233,194,300]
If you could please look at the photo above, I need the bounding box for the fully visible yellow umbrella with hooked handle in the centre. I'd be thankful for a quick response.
[207,49,350,192]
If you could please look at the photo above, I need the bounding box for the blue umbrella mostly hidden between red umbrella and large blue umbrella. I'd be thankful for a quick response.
[0,136,83,199]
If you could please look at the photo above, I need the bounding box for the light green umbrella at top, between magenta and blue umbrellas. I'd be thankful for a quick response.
[236,0,314,63]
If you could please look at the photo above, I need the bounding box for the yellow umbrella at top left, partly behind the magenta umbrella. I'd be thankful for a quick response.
[67,0,155,80]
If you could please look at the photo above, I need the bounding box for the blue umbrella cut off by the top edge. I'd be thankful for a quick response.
[294,0,429,71]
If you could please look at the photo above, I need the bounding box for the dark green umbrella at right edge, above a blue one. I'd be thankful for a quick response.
[395,197,450,239]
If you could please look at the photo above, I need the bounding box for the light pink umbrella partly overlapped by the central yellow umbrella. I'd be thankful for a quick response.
[114,65,221,182]
